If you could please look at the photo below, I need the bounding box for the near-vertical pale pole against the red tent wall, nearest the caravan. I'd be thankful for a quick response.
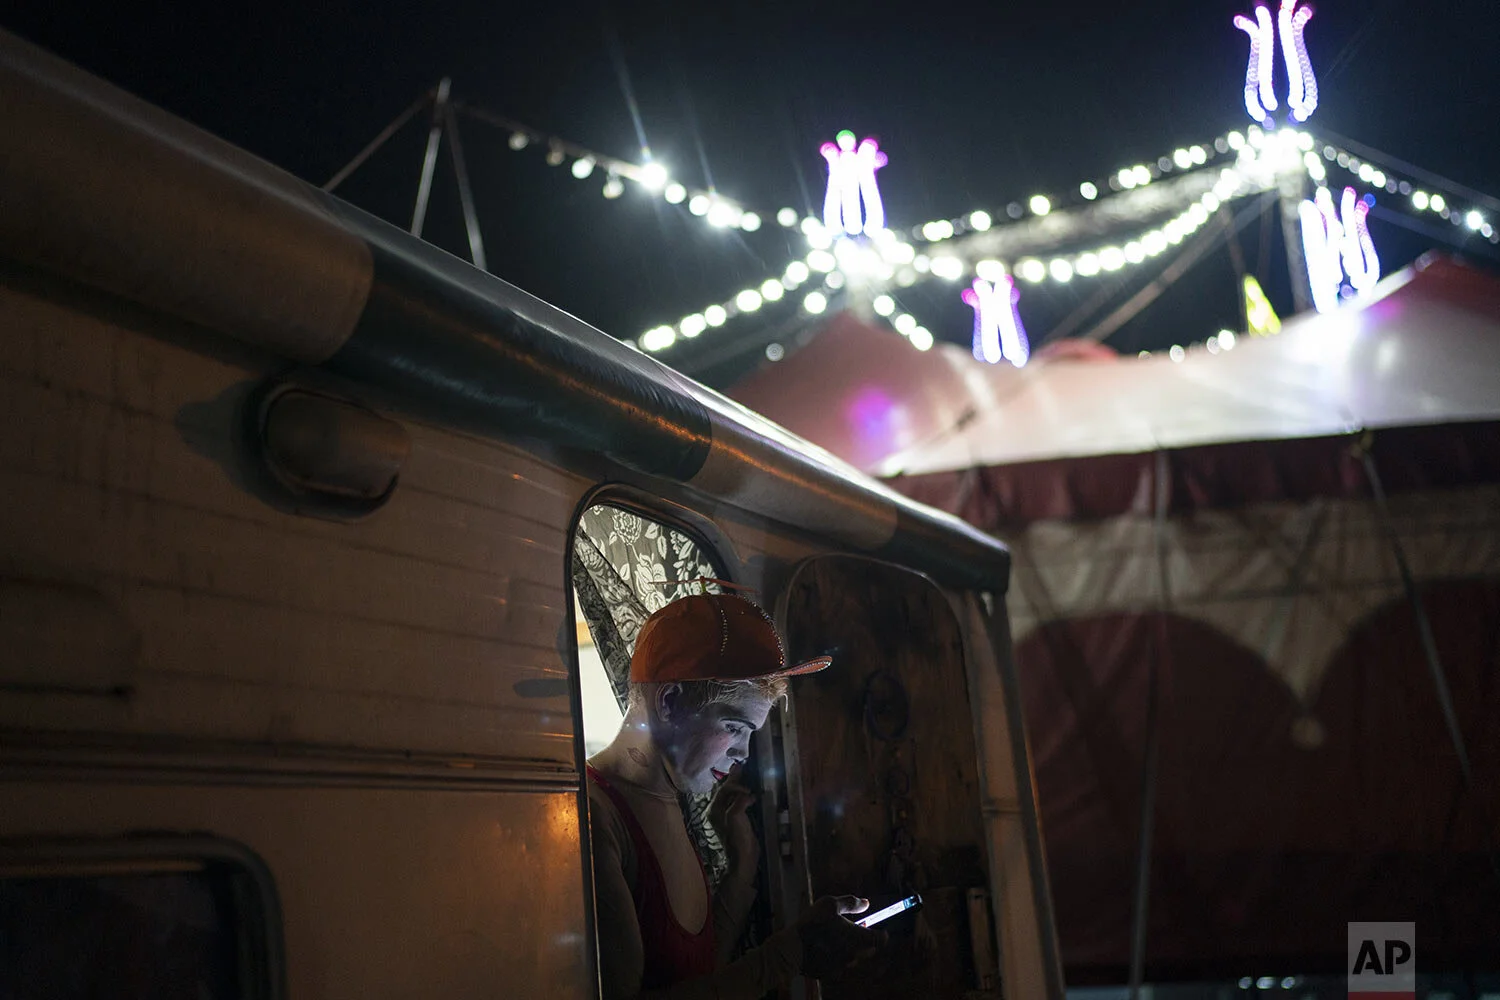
[1130,451,1172,1000]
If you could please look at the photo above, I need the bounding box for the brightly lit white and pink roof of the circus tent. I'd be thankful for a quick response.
[731,258,1500,475]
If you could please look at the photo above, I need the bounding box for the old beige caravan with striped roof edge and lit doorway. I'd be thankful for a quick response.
[0,36,1062,1000]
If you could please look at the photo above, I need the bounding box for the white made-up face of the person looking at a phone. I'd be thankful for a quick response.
[653,684,771,795]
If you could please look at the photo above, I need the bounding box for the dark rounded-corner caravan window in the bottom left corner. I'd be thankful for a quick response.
[0,852,281,1000]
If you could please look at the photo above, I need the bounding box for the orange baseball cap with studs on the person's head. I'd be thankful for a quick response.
[630,594,834,682]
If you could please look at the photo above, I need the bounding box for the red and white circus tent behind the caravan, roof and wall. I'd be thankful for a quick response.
[731,258,1500,982]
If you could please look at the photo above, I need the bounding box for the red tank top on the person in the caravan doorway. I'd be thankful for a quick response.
[588,766,714,990]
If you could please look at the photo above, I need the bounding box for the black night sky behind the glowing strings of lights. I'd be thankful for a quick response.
[0,0,1500,385]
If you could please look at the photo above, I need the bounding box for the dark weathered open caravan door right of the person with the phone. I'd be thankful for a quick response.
[783,556,1020,1000]
